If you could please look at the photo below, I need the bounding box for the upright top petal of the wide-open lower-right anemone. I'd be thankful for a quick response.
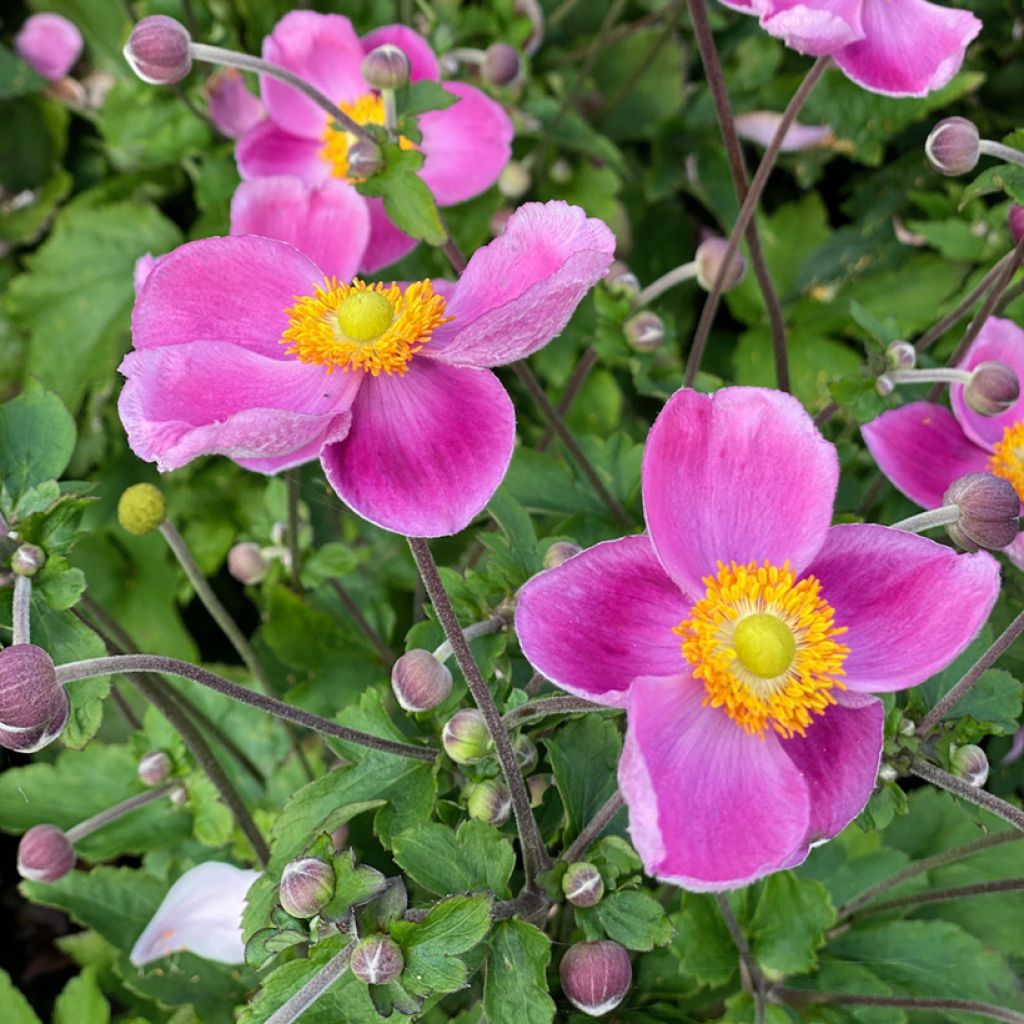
[643,387,839,597]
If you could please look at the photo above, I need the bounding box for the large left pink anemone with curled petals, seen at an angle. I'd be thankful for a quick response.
[119,202,614,537]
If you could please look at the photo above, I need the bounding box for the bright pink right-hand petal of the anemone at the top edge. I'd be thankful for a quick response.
[834,0,981,96]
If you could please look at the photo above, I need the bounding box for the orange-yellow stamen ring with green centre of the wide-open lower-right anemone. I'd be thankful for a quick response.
[675,562,850,738]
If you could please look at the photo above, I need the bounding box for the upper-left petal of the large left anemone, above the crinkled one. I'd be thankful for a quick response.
[132,236,324,362]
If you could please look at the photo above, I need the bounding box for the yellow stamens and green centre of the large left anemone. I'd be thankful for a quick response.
[281,278,454,377]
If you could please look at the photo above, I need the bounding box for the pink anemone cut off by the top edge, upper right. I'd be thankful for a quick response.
[722,0,981,96]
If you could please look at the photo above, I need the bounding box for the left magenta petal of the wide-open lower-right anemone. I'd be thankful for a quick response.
[515,535,690,708]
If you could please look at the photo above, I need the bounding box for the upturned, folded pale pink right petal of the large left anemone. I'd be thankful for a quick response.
[427,202,615,367]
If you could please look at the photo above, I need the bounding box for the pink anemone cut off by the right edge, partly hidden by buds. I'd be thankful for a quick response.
[861,316,1024,568]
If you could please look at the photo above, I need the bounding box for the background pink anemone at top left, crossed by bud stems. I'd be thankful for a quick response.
[236,10,513,273]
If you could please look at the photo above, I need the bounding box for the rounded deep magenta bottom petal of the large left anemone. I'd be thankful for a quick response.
[322,358,515,537]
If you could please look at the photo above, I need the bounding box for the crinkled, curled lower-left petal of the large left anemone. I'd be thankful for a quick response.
[118,341,361,472]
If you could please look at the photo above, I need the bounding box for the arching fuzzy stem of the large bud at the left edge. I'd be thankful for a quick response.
[57,654,437,761]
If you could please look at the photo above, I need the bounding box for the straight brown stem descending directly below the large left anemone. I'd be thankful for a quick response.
[407,537,550,890]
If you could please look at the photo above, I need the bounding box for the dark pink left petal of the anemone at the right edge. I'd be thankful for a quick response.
[860,401,988,509]
